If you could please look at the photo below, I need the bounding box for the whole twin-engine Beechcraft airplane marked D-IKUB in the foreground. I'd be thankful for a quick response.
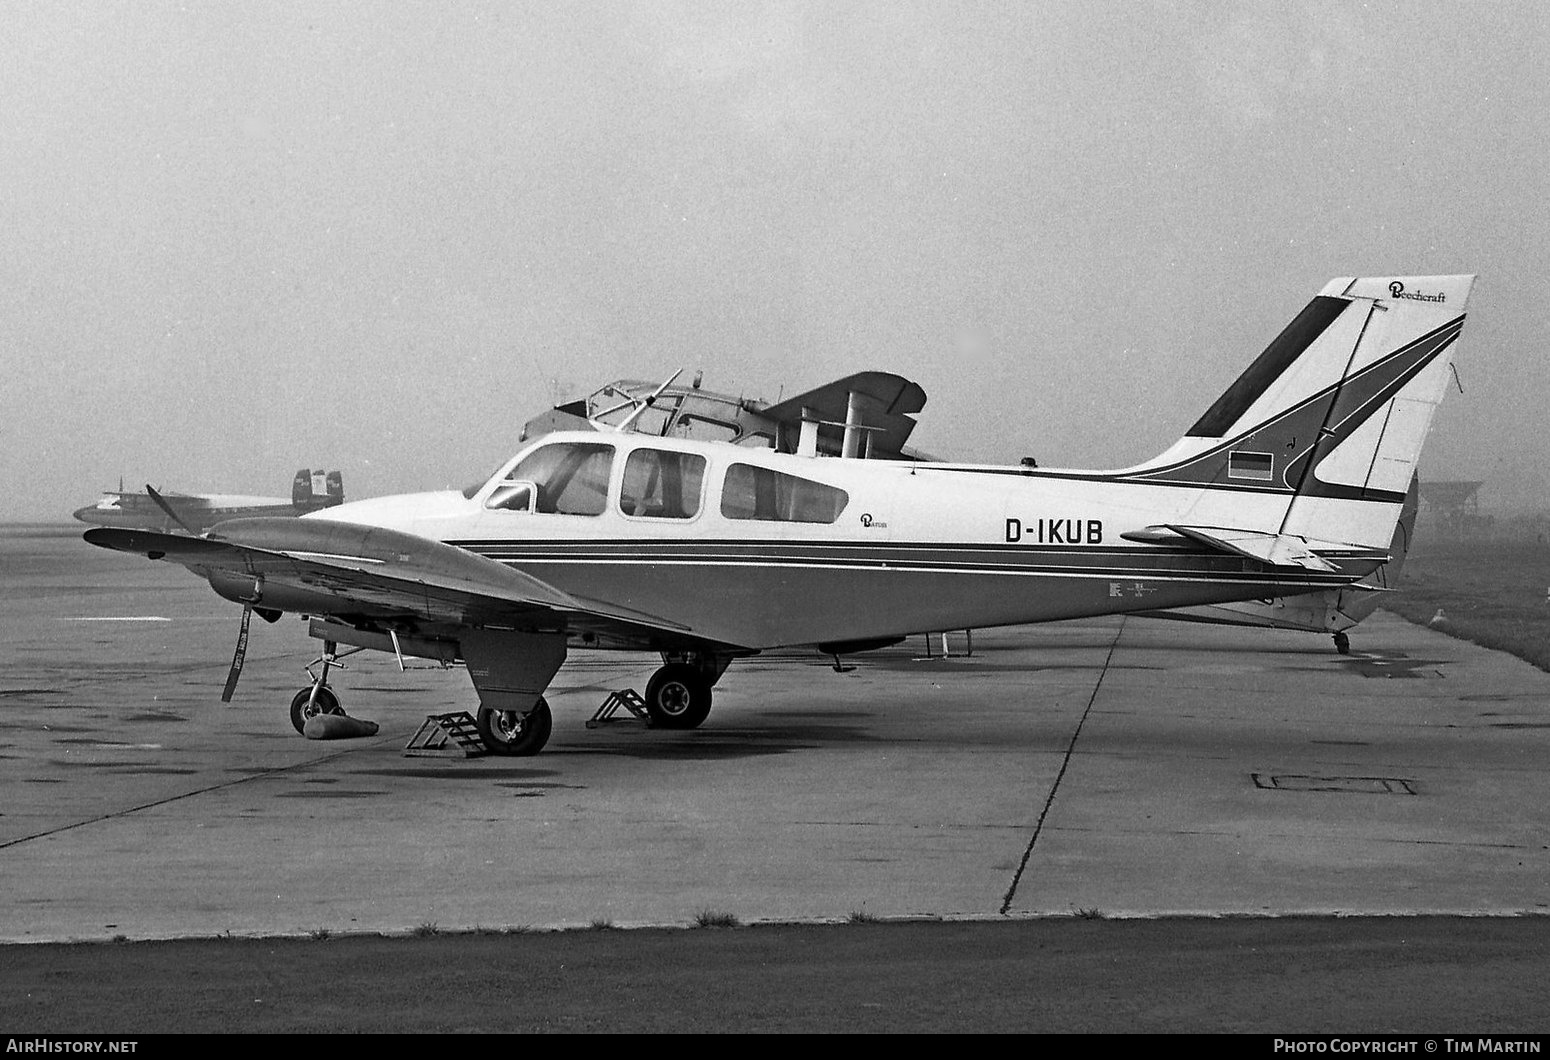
[85,276,1474,755]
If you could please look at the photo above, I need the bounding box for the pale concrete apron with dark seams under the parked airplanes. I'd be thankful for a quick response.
[0,528,1550,942]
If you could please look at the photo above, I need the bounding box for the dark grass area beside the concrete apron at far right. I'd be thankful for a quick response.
[1383,541,1550,671]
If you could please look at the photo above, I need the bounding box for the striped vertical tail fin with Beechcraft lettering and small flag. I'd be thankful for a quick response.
[1121,276,1474,549]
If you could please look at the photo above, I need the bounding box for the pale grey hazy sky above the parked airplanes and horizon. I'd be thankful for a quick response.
[0,0,1550,521]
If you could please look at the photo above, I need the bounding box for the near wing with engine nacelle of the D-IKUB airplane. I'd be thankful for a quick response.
[85,518,732,649]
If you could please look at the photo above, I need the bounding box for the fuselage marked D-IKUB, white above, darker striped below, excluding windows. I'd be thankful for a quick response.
[305,432,1372,648]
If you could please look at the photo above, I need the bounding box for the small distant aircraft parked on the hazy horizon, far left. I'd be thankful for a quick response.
[74,468,344,533]
